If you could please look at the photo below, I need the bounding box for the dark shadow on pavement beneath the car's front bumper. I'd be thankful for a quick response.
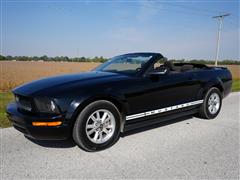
[25,136,76,148]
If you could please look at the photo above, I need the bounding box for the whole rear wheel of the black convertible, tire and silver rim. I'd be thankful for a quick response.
[199,87,222,119]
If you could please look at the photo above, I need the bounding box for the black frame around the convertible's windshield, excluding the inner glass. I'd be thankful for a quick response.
[94,53,163,76]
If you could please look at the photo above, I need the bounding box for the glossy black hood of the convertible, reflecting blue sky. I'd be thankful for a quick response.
[13,71,126,96]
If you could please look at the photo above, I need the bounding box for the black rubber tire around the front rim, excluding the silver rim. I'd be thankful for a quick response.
[73,100,121,152]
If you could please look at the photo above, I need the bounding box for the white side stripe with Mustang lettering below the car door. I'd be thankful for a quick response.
[126,100,203,120]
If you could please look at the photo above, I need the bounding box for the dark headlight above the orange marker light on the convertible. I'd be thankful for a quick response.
[34,97,59,114]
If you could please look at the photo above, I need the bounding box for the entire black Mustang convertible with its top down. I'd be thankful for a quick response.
[7,53,232,151]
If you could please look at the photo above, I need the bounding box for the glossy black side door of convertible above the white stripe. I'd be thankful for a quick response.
[126,69,199,114]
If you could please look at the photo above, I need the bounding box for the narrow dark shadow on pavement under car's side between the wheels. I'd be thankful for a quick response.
[121,115,194,137]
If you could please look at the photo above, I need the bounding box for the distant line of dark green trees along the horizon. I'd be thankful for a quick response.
[0,55,240,65]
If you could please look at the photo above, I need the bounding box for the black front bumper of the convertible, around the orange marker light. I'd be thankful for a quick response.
[7,103,71,140]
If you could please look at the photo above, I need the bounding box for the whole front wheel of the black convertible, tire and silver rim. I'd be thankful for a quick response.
[73,100,121,151]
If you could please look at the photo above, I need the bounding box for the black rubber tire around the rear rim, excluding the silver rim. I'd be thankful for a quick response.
[199,87,222,119]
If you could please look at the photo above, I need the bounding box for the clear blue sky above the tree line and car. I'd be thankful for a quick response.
[0,0,240,60]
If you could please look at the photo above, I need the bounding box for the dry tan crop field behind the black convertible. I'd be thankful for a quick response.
[0,61,240,91]
